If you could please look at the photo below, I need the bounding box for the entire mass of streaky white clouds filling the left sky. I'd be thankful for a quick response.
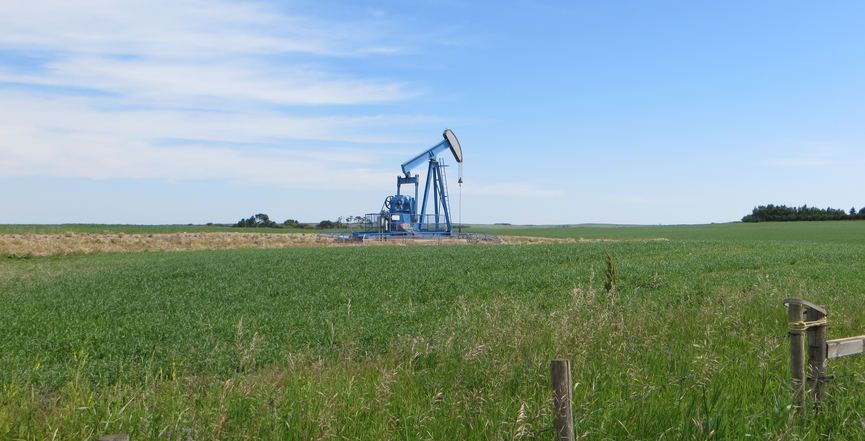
[0,0,436,188]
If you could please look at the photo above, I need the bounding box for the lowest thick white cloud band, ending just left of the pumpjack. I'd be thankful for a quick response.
[0,120,394,190]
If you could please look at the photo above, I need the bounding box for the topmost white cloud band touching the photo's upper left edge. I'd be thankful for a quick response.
[0,0,395,59]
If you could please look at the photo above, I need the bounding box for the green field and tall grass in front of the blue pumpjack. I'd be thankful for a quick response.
[0,222,865,440]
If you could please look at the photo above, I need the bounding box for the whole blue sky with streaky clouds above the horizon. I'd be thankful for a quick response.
[0,0,865,224]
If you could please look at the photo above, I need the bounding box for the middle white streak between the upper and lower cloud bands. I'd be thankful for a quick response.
[0,56,417,109]
